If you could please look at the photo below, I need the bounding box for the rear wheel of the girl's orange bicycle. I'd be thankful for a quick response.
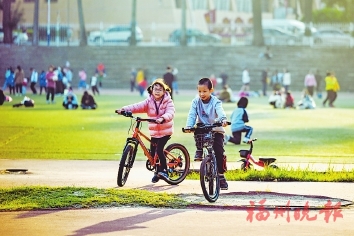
[164,143,190,185]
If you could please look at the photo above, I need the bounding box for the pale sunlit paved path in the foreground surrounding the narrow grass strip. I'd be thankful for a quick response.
[0,160,354,236]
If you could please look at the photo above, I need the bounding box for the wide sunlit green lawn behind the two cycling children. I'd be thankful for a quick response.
[0,91,354,163]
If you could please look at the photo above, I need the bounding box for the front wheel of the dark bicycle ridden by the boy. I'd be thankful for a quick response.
[200,156,220,202]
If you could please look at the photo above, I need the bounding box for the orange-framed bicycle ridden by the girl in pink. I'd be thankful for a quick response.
[116,111,190,187]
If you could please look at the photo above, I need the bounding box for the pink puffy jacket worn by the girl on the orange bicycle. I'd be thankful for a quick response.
[122,92,175,138]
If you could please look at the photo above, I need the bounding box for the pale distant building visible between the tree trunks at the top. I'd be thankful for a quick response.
[0,0,321,41]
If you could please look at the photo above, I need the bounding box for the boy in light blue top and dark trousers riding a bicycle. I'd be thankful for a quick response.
[186,78,228,190]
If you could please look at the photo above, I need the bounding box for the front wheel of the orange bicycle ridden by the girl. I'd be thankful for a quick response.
[117,144,136,187]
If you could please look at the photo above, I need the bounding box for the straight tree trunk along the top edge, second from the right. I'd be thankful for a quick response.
[252,0,264,46]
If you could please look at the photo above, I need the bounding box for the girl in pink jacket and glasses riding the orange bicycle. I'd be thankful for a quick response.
[117,79,175,183]
